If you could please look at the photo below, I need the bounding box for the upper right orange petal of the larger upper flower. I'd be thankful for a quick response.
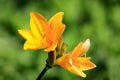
[49,12,64,29]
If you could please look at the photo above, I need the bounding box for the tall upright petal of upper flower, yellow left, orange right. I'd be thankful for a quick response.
[30,12,49,40]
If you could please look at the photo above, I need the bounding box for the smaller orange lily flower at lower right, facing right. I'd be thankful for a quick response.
[55,39,96,77]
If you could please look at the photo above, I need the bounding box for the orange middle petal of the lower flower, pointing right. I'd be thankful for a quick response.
[72,57,96,70]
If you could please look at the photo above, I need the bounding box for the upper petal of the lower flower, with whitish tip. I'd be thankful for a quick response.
[72,39,90,57]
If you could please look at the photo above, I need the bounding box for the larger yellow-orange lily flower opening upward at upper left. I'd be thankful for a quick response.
[18,12,65,51]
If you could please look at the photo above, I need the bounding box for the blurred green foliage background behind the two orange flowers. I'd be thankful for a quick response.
[0,0,120,80]
